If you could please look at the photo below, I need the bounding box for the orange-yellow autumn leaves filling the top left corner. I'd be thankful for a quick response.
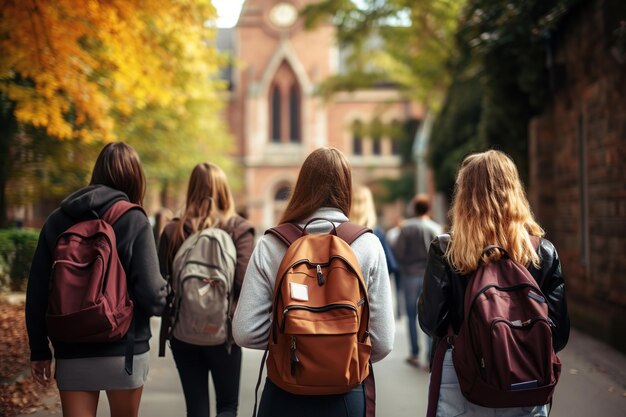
[0,0,219,140]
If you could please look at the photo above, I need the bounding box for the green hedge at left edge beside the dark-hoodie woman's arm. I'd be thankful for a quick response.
[0,229,39,291]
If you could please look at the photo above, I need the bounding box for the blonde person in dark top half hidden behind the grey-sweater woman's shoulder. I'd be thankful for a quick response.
[349,185,398,276]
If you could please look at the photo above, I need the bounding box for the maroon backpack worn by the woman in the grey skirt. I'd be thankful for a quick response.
[46,200,145,343]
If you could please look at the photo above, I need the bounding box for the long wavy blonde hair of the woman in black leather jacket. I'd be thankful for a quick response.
[446,150,544,275]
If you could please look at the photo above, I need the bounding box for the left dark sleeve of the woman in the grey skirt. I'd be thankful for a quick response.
[25,226,52,360]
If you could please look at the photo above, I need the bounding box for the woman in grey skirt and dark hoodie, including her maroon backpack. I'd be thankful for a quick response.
[26,142,166,417]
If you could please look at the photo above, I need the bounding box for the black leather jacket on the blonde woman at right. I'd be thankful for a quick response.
[418,234,570,358]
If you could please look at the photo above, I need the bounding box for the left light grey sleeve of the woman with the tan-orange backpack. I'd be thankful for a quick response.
[233,236,277,349]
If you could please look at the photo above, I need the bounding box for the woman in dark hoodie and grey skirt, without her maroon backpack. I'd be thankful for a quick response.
[26,142,166,417]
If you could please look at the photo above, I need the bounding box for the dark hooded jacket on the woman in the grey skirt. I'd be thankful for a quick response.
[26,185,166,361]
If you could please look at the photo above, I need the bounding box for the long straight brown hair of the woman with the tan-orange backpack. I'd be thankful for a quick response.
[280,147,352,223]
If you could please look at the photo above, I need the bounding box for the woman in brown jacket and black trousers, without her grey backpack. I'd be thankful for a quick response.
[159,163,254,417]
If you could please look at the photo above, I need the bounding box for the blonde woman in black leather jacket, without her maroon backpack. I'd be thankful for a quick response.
[418,150,570,417]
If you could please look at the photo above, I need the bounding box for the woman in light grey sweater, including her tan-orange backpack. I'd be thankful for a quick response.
[233,148,395,417]
